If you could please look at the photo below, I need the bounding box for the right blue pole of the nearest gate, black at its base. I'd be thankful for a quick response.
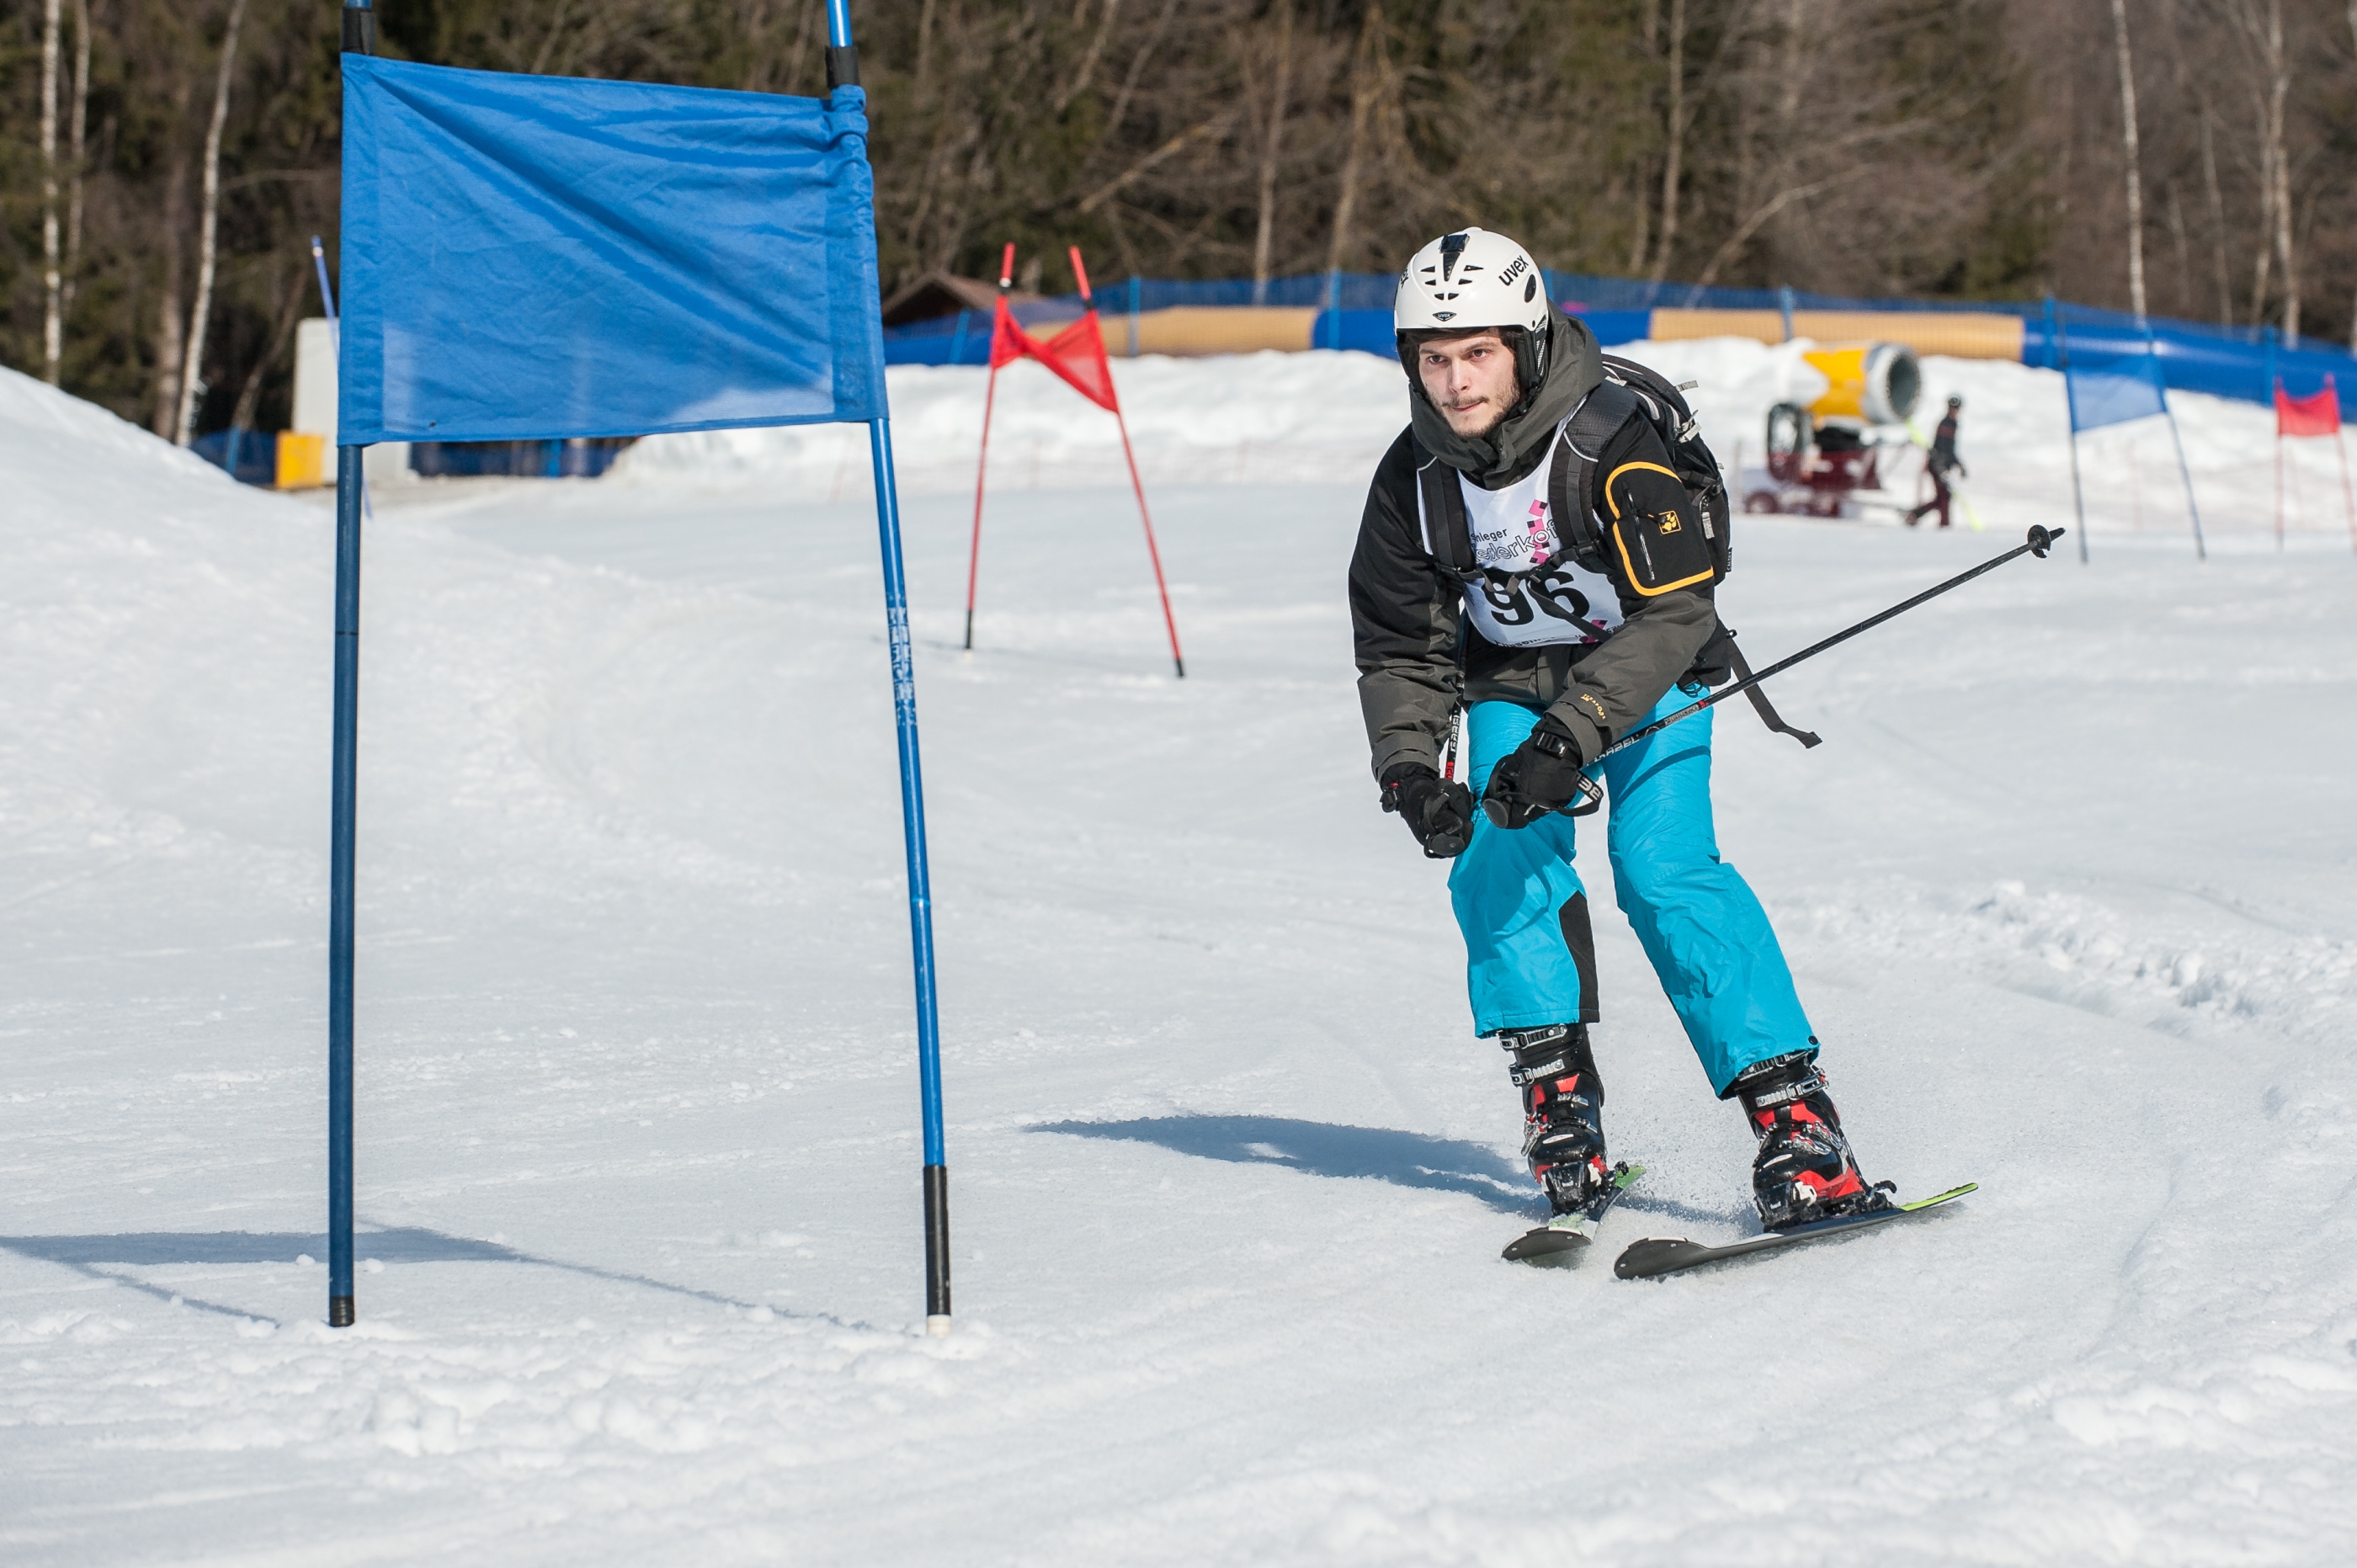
[827,0,950,1335]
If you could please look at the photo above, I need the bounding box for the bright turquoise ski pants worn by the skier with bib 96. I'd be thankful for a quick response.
[1450,686,1817,1094]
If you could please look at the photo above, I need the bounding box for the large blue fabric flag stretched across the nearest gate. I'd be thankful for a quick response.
[337,54,886,445]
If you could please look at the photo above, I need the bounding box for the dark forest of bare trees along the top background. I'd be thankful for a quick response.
[0,0,2357,436]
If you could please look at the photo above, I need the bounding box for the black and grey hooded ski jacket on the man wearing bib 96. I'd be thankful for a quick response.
[1350,415,1735,778]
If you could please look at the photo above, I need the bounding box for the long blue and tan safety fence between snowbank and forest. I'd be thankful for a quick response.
[884,271,2357,417]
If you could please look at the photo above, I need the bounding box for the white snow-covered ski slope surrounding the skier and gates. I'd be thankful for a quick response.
[0,344,2357,1568]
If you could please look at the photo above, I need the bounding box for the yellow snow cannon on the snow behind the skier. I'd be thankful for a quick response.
[1744,339,1923,517]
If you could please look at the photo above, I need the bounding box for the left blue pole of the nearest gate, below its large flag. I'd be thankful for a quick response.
[327,445,368,1327]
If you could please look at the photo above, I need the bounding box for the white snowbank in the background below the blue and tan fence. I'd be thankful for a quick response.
[615,338,2348,542]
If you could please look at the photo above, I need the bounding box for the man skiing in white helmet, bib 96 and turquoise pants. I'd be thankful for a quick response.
[1350,229,1888,1229]
